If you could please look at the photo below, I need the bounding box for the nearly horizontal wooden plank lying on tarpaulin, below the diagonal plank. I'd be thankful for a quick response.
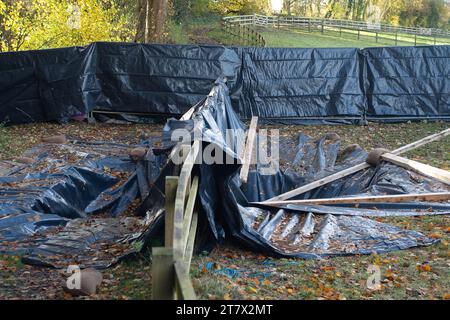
[257,192,450,206]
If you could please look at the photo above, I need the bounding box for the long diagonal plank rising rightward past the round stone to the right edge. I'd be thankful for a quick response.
[263,128,450,203]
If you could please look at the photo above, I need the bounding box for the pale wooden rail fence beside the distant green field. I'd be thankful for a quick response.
[222,14,450,46]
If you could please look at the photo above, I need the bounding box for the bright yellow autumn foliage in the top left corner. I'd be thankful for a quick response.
[0,0,134,51]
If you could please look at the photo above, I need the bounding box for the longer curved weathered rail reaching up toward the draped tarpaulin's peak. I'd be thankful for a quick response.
[173,140,201,260]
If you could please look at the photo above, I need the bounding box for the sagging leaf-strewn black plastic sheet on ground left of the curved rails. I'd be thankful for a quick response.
[0,138,167,267]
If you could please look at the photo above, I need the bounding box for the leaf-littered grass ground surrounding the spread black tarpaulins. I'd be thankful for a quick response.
[0,123,450,300]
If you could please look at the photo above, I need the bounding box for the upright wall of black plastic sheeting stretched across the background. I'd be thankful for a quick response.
[0,43,450,124]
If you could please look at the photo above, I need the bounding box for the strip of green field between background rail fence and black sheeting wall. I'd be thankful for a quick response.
[259,28,450,48]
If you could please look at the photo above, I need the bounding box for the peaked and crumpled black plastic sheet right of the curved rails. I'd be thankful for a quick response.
[160,81,450,258]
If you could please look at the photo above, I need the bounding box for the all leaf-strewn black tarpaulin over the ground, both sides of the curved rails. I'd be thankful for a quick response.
[0,80,450,268]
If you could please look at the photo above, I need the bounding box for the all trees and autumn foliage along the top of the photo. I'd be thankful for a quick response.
[0,0,450,52]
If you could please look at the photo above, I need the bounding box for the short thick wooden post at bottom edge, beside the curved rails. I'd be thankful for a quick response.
[152,247,175,300]
